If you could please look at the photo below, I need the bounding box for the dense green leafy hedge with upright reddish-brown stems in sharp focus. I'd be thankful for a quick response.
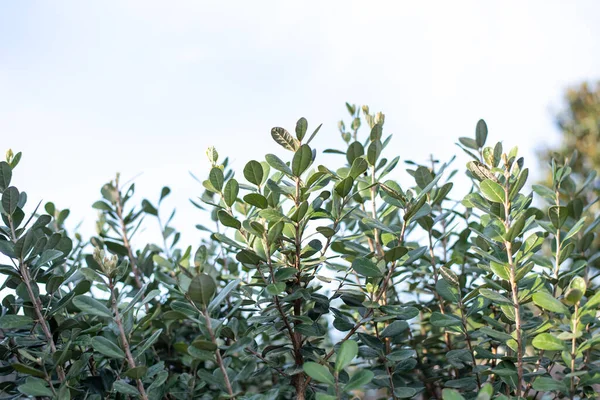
[0,105,600,400]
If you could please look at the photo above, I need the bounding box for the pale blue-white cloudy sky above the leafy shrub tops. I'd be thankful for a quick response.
[0,1,600,245]
